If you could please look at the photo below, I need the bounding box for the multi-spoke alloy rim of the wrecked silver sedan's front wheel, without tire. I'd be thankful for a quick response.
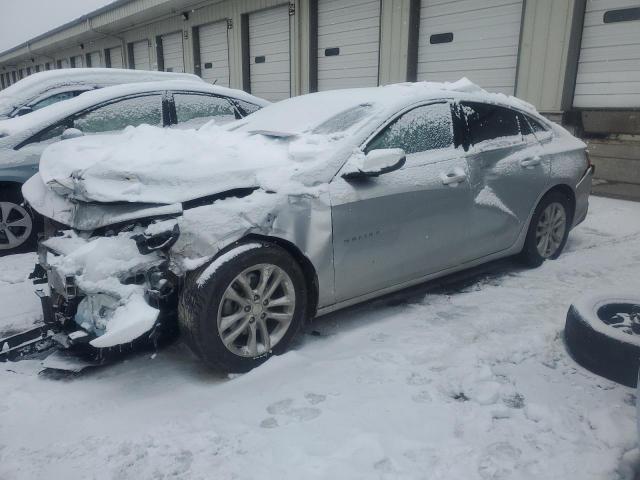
[217,263,296,358]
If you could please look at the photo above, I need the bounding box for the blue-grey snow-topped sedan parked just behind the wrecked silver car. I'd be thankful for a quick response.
[0,81,268,255]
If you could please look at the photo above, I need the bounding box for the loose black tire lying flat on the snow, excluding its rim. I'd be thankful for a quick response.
[564,295,640,388]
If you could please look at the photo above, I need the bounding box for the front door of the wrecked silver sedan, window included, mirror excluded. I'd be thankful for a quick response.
[330,103,471,301]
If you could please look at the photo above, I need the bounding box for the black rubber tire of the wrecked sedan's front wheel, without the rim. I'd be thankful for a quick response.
[193,244,308,372]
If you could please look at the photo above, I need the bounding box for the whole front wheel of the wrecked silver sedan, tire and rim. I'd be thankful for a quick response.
[178,242,308,373]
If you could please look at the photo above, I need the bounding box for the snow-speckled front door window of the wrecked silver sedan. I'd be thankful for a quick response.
[366,103,453,155]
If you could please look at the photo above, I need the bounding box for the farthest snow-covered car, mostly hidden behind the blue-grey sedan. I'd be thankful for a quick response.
[0,68,203,120]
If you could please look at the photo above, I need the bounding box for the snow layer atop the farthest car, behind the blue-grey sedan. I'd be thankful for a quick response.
[0,68,204,113]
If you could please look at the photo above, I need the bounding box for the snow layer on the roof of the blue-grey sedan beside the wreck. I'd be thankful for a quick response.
[0,77,269,136]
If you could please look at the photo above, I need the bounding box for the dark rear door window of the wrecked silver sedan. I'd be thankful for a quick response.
[462,103,522,149]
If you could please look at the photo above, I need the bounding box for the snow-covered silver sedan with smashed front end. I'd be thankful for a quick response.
[23,79,593,372]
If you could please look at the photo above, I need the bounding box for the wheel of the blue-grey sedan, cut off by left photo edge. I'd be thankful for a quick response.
[0,188,38,256]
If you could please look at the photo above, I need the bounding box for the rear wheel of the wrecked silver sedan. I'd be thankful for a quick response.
[520,191,573,267]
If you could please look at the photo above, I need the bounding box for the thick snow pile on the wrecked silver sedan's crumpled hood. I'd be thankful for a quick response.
[40,122,336,204]
